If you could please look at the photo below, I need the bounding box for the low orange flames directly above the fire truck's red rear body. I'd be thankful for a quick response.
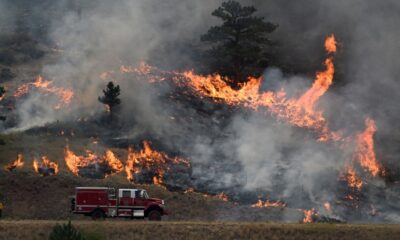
[64,146,124,176]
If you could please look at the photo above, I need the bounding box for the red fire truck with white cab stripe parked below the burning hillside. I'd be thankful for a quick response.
[71,187,168,221]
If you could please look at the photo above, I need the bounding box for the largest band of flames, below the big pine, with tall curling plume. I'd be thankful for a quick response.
[181,35,342,141]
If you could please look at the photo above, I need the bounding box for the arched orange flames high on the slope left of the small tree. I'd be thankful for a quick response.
[14,76,74,109]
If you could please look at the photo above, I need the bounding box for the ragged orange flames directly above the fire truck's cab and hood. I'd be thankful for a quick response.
[125,141,190,185]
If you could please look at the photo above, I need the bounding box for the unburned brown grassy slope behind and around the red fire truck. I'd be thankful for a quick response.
[0,132,294,221]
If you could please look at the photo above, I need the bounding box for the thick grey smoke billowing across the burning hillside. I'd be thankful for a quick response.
[0,0,400,221]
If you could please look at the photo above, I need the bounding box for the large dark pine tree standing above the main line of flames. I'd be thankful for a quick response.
[201,1,277,86]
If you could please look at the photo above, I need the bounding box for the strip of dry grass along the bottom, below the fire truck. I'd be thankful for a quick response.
[0,220,400,240]
